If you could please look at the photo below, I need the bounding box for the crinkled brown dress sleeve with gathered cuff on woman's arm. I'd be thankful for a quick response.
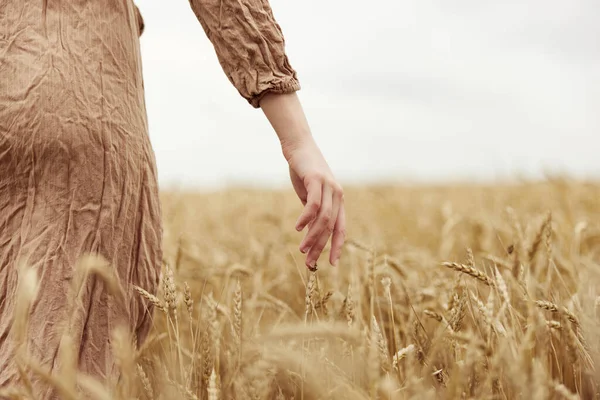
[189,0,300,108]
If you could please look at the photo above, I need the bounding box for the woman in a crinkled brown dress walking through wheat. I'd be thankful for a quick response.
[0,0,345,398]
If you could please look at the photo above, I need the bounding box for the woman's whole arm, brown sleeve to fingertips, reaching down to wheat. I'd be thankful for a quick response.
[190,0,345,268]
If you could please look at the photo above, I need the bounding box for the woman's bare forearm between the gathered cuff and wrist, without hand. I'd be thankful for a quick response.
[260,93,314,160]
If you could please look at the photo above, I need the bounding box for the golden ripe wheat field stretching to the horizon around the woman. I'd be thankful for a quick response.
[2,179,600,400]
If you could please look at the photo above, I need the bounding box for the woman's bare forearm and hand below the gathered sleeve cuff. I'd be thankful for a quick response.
[260,93,346,269]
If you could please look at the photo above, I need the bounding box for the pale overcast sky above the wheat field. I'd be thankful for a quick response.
[137,0,600,188]
